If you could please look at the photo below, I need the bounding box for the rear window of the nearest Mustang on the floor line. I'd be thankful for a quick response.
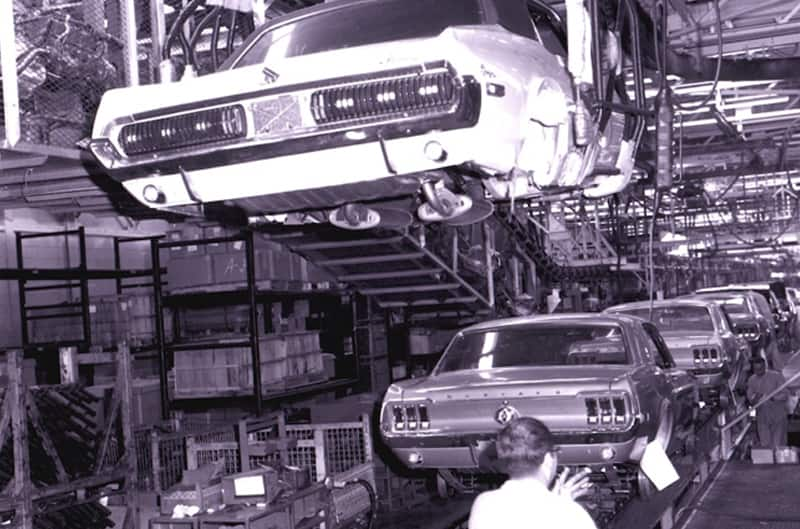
[436,323,629,374]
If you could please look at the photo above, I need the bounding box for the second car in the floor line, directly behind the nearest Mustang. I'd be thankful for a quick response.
[606,299,750,406]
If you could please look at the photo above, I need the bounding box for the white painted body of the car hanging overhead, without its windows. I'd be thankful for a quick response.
[91,0,620,218]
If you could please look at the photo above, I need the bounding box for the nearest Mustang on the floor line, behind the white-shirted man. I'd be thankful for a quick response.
[380,314,697,508]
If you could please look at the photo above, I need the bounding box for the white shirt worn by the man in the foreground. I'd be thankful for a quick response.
[469,478,597,529]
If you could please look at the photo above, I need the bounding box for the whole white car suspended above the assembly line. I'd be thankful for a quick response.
[89,0,636,229]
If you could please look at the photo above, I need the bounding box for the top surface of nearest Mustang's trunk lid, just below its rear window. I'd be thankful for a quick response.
[400,365,632,400]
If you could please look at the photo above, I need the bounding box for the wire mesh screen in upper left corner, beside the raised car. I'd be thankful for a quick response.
[0,0,136,148]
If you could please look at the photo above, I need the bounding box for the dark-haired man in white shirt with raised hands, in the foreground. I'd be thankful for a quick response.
[469,417,596,529]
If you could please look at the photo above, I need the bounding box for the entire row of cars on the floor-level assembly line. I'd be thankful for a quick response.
[380,285,796,512]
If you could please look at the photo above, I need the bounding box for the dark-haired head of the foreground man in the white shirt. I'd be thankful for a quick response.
[497,417,558,482]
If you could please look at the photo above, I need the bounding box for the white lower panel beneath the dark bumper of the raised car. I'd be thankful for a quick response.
[113,125,517,213]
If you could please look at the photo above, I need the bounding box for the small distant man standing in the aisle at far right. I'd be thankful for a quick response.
[747,357,789,450]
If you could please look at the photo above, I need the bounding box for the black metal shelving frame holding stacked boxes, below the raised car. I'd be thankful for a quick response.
[151,231,359,418]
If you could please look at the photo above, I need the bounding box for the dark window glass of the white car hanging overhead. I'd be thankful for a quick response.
[228,0,485,68]
